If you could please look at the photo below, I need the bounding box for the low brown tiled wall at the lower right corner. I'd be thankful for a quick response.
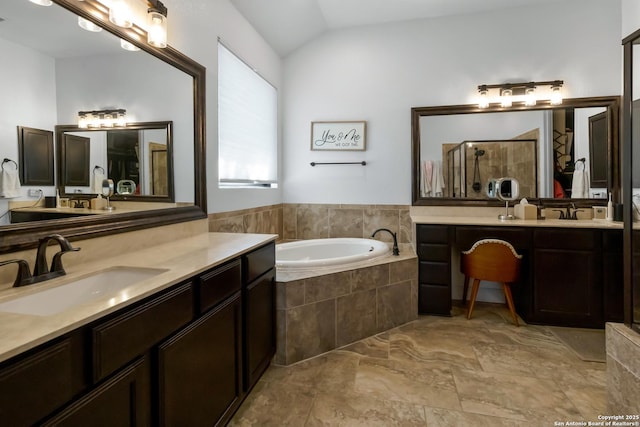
[606,323,640,415]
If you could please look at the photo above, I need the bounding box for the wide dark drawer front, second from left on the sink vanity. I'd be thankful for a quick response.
[92,283,193,381]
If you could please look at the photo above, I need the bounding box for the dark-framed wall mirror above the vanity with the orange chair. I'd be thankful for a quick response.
[411,96,620,206]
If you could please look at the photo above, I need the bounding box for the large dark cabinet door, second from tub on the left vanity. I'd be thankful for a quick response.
[158,292,242,427]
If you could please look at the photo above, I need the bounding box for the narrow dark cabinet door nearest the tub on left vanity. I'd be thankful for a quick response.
[244,270,275,390]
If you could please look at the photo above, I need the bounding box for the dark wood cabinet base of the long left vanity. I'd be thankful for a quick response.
[0,243,275,427]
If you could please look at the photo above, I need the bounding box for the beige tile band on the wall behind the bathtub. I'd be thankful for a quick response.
[209,203,413,243]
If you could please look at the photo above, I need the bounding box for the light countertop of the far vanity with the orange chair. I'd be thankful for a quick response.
[411,215,624,230]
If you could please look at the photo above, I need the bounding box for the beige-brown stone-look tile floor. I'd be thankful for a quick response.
[229,304,607,427]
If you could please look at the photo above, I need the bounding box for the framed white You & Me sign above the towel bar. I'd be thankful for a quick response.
[311,121,367,151]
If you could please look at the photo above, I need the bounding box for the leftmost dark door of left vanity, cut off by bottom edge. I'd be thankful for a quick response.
[44,358,151,427]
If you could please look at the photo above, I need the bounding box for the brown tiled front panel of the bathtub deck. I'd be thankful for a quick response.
[275,250,418,365]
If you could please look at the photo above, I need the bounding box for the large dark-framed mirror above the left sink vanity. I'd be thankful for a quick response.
[0,0,206,252]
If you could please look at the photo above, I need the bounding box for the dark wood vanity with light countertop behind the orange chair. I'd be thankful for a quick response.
[412,214,623,328]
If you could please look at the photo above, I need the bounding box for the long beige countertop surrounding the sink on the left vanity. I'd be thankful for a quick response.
[0,233,277,361]
